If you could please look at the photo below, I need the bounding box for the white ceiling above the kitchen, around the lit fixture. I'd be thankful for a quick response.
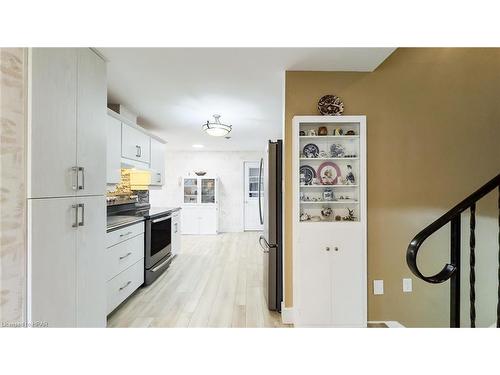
[98,48,394,151]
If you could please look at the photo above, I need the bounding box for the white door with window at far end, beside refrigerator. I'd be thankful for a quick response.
[243,161,264,231]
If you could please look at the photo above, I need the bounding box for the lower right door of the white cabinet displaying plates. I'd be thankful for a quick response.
[331,223,367,327]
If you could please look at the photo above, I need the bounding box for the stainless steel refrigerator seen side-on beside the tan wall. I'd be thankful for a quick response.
[259,139,283,311]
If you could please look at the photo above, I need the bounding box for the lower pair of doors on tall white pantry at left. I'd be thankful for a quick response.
[28,196,106,327]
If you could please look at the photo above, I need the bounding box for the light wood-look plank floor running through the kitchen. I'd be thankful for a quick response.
[108,232,292,327]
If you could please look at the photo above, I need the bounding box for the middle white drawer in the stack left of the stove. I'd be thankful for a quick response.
[106,233,144,280]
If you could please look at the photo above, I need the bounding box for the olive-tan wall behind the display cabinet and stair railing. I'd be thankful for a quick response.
[285,48,500,326]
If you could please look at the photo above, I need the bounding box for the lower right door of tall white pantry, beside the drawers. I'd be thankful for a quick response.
[76,196,106,327]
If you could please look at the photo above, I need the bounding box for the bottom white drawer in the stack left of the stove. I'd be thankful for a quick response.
[106,259,144,314]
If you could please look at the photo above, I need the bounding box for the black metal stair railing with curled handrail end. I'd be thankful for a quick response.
[406,174,500,328]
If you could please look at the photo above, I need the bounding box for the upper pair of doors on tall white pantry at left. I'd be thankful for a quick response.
[28,48,106,198]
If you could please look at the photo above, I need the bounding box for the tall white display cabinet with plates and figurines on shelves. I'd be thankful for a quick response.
[292,116,367,327]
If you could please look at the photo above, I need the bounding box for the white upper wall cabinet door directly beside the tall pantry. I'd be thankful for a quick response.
[106,115,122,184]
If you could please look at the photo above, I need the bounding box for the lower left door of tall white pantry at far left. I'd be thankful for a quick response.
[28,197,76,327]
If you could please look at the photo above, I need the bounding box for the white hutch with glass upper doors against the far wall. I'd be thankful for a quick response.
[181,176,219,234]
